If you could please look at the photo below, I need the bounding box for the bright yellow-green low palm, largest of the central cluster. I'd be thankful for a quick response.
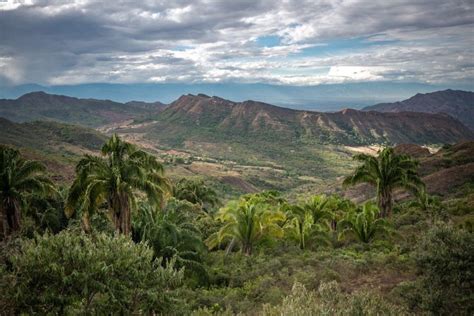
[206,194,285,256]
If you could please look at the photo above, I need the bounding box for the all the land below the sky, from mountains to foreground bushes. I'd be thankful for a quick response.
[0,91,474,315]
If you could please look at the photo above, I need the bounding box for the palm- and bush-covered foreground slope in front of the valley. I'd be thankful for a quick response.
[0,132,474,315]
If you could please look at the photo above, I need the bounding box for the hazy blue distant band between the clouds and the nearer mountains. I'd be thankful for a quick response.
[0,82,474,111]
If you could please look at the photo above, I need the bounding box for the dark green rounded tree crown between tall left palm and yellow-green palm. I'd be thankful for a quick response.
[173,179,219,212]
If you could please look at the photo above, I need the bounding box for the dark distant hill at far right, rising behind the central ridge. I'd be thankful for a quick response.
[363,90,474,130]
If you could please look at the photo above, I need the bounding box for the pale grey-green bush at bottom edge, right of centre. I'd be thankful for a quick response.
[262,282,407,316]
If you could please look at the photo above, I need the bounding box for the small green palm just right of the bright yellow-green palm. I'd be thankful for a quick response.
[282,195,331,250]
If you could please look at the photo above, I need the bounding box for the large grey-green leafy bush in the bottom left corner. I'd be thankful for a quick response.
[0,231,183,315]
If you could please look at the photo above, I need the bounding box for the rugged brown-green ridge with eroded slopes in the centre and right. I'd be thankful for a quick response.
[124,94,474,145]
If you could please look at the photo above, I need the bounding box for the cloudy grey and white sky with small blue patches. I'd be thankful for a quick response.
[0,0,474,86]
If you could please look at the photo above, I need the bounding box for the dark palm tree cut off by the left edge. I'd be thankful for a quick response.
[0,146,53,237]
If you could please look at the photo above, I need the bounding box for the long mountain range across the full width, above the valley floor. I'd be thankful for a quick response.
[0,91,474,146]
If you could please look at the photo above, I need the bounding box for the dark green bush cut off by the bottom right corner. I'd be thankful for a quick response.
[405,225,474,315]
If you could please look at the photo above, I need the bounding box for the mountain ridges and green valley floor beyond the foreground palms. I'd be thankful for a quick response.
[0,88,474,193]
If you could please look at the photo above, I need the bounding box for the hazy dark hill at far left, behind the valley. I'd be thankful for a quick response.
[0,92,164,127]
